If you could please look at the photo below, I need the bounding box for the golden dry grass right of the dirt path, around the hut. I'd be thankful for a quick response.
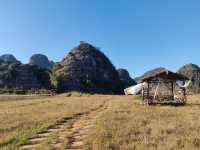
[85,95,200,150]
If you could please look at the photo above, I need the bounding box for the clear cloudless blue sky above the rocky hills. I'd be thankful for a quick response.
[0,0,200,77]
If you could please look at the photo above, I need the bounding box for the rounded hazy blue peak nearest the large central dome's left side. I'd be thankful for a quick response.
[29,54,55,70]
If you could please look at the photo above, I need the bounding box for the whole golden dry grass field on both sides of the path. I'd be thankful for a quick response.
[0,95,200,150]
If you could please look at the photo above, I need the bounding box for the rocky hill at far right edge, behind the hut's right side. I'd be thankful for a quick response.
[178,64,200,92]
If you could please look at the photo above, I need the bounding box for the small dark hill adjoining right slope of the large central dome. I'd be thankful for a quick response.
[117,69,137,88]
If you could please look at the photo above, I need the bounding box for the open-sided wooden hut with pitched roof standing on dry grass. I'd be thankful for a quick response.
[140,68,188,104]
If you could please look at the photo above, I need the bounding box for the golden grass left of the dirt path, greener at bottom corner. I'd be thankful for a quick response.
[0,95,105,149]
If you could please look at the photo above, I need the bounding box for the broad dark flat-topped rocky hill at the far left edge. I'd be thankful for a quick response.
[0,60,51,90]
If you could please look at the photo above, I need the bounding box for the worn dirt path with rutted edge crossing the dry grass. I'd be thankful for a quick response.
[21,101,110,150]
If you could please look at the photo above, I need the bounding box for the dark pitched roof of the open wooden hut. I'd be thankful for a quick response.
[140,68,189,82]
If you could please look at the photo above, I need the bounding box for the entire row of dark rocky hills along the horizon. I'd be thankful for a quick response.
[0,45,200,94]
